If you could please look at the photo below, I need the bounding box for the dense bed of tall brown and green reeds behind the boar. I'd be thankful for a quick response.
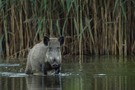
[0,0,135,58]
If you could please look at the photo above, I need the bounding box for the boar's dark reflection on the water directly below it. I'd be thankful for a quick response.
[26,76,62,90]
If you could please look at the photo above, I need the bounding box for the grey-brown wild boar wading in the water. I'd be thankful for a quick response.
[25,36,64,74]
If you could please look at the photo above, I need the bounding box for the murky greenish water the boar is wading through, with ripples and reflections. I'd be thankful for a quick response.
[0,56,135,90]
